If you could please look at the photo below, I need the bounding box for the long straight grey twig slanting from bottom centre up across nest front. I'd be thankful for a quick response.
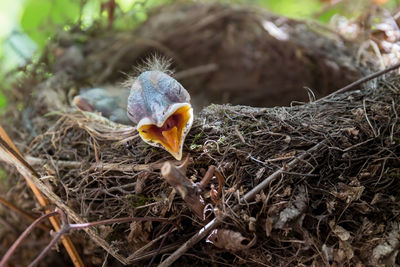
[159,141,325,267]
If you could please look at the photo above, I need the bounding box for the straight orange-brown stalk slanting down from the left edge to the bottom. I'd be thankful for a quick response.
[0,125,83,267]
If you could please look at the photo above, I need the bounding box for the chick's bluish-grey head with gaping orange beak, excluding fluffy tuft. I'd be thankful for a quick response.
[127,71,193,160]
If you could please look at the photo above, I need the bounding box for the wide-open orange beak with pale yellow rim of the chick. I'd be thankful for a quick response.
[138,103,193,160]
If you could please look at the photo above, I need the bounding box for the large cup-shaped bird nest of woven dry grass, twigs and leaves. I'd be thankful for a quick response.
[1,2,400,266]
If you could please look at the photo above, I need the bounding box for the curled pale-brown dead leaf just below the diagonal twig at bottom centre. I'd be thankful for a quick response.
[206,229,256,252]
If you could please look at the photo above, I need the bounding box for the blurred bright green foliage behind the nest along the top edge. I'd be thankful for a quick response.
[0,0,400,112]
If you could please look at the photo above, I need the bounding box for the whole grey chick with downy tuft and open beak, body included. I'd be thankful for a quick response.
[74,57,193,160]
